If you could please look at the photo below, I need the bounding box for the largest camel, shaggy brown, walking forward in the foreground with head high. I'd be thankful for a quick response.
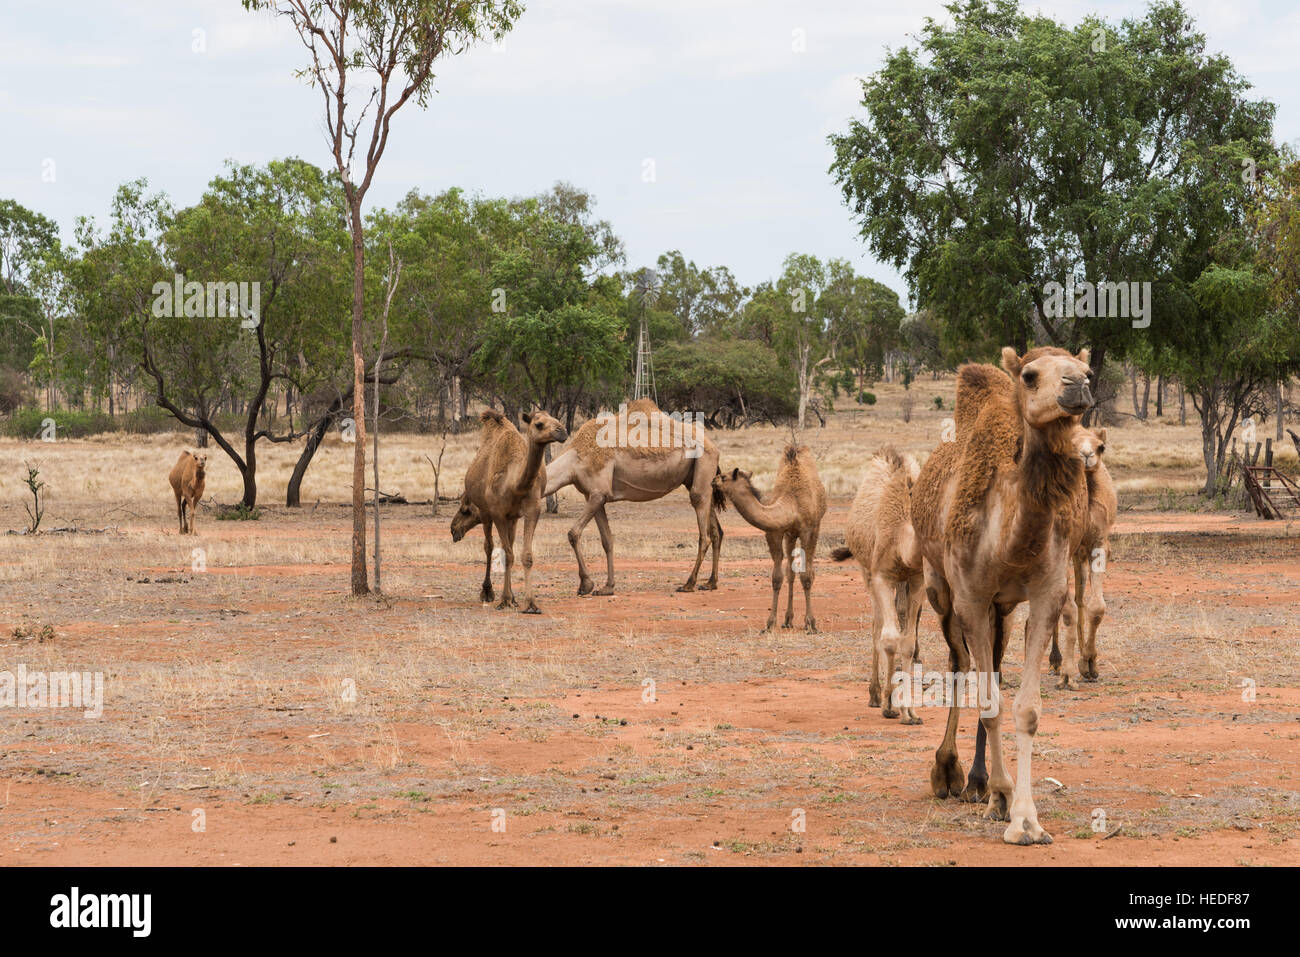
[913,347,1093,845]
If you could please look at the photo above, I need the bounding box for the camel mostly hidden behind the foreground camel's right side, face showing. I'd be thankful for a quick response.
[1048,425,1119,688]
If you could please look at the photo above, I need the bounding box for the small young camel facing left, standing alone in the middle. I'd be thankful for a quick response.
[714,445,826,635]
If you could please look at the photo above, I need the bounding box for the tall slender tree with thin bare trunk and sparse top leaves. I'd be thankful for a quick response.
[243,0,523,594]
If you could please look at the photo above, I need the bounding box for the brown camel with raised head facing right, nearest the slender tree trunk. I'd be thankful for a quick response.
[451,408,568,615]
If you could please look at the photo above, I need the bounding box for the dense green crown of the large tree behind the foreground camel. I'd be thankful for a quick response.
[831,0,1274,365]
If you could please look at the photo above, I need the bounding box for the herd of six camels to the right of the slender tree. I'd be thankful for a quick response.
[451,347,1117,844]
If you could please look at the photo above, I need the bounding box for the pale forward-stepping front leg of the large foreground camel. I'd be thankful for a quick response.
[995,575,1069,844]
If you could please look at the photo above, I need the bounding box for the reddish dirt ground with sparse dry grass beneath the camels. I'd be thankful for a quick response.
[0,495,1300,865]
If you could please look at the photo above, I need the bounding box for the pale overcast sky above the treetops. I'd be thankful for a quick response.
[0,0,1300,294]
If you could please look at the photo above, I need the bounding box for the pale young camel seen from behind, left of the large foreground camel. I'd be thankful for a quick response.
[831,446,926,724]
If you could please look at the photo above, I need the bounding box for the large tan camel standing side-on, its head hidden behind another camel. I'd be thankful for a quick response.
[545,399,727,596]
